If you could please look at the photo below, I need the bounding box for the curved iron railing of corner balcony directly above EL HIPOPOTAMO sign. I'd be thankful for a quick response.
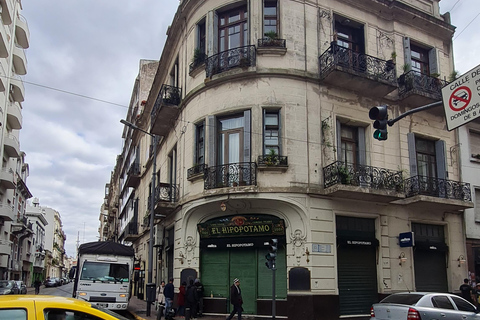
[204,162,257,190]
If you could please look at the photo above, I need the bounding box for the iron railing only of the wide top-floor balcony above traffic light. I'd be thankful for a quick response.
[319,44,397,86]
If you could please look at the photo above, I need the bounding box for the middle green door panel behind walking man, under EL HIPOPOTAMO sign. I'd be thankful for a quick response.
[229,249,257,314]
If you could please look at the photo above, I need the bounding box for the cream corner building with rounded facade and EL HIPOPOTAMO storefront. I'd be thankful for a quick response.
[115,0,473,319]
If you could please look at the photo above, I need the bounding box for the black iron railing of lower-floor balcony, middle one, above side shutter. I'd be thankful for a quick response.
[323,161,403,192]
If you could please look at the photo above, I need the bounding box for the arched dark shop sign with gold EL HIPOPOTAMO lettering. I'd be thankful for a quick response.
[197,214,285,239]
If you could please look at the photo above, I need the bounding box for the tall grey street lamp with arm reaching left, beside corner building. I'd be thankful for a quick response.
[120,119,160,316]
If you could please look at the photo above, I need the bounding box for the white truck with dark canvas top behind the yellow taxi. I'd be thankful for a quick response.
[72,241,135,310]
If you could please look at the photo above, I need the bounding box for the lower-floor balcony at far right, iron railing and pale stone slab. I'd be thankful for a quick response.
[402,176,473,212]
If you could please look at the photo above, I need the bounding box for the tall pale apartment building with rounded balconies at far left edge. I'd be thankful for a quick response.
[0,0,31,281]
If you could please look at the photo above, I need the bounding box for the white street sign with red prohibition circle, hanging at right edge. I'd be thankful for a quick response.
[442,65,480,131]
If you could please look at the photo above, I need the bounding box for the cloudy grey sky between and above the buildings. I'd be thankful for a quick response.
[20,0,480,256]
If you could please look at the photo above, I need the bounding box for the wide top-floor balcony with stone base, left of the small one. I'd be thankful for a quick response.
[319,44,397,97]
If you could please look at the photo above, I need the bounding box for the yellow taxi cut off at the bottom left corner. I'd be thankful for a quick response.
[0,295,128,320]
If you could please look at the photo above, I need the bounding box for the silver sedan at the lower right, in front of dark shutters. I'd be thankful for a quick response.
[370,292,480,320]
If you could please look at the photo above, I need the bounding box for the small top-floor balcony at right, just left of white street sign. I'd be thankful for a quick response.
[398,70,448,106]
